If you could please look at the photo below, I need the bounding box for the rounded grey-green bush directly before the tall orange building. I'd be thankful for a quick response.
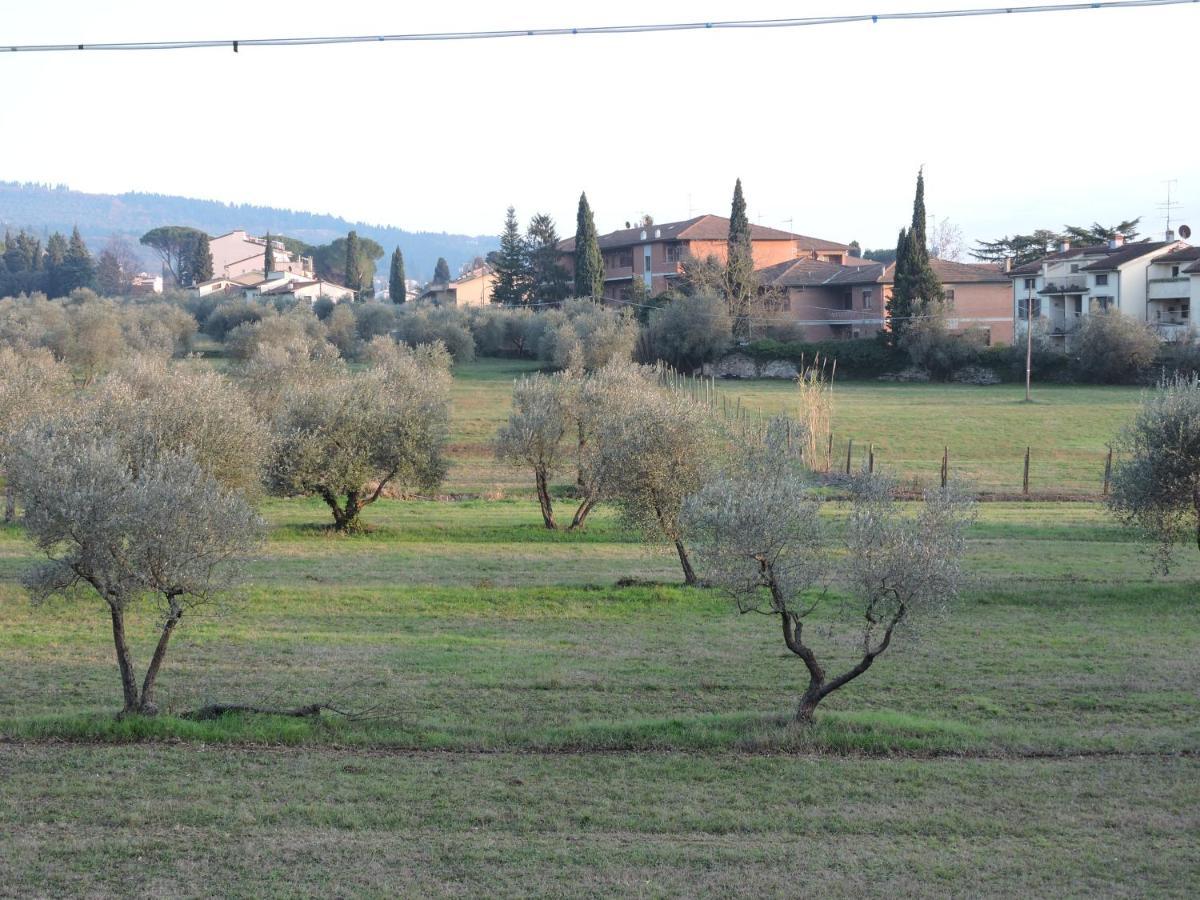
[638,294,732,372]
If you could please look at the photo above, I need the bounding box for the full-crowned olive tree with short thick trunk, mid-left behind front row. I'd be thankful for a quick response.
[268,337,450,533]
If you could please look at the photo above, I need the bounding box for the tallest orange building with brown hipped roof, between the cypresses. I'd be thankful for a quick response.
[558,215,850,300]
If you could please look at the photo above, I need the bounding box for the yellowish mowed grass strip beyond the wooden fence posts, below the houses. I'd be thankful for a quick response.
[446,360,1141,494]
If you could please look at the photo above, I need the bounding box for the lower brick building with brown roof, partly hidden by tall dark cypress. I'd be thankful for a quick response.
[758,257,1013,343]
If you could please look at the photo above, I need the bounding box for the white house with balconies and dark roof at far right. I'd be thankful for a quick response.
[1009,233,1192,340]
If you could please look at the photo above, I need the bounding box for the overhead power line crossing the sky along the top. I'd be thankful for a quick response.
[0,0,1200,53]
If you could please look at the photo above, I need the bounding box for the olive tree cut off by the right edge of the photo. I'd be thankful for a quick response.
[1109,376,1200,570]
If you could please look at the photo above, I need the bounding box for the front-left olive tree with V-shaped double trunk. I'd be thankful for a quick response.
[10,422,262,715]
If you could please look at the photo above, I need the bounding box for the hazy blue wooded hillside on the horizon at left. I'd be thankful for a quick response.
[0,181,499,281]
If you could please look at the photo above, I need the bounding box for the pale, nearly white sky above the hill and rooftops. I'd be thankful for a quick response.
[0,0,1200,247]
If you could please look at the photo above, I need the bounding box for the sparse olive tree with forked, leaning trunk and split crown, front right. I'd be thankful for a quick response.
[682,432,972,724]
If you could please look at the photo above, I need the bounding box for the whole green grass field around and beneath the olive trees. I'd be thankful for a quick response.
[0,361,1200,898]
